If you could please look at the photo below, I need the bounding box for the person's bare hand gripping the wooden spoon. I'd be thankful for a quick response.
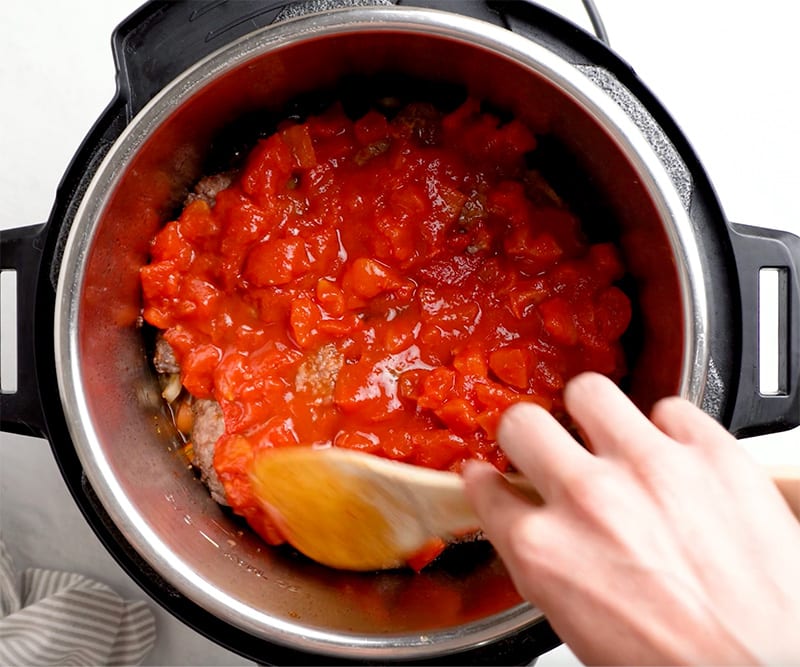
[464,373,800,664]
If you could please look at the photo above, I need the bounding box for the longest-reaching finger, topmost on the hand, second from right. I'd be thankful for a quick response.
[564,373,665,458]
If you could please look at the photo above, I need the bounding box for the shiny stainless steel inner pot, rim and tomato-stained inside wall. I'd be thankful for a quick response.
[54,7,708,660]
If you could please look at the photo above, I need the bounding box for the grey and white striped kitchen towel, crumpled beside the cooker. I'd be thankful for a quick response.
[0,540,156,665]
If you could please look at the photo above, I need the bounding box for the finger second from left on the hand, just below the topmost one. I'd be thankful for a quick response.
[497,403,592,501]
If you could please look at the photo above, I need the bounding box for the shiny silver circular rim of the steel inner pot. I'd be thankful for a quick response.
[54,7,708,659]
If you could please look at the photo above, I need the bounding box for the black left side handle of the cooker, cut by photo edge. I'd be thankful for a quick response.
[0,225,48,438]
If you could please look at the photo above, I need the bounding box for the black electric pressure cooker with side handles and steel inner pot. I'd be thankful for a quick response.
[0,0,800,664]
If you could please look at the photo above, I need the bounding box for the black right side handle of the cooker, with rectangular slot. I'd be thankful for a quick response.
[729,224,800,437]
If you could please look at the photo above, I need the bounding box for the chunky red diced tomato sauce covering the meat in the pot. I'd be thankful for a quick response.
[141,99,631,555]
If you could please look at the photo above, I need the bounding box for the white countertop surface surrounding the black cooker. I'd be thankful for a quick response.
[0,0,800,667]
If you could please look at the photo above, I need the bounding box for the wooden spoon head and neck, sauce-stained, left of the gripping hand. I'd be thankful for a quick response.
[251,447,541,571]
